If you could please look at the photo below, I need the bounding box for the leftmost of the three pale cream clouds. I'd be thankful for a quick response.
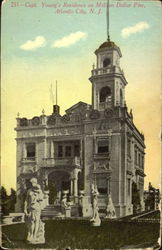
[20,36,46,50]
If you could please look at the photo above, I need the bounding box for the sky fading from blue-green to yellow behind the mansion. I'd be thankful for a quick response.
[1,0,161,193]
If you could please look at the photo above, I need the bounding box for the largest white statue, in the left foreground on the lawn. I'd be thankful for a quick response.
[24,178,45,244]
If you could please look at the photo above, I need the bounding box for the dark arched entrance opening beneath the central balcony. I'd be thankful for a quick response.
[48,171,70,204]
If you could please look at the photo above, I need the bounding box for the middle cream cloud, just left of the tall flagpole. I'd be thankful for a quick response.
[51,31,87,48]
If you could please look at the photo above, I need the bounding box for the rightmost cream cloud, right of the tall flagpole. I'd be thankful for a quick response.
[121,22,150,37]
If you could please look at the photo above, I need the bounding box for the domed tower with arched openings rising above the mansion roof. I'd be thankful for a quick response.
[89,38,127,111]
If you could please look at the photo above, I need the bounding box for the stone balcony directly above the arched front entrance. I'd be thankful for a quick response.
[43,156,81,167]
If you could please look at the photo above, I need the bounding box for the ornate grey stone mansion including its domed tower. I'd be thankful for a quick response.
[16,39,145,217]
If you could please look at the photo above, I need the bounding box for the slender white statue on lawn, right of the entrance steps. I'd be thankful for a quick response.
[90,184,101,226]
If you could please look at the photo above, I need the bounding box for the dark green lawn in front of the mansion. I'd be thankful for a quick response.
[2,219,159,250]
